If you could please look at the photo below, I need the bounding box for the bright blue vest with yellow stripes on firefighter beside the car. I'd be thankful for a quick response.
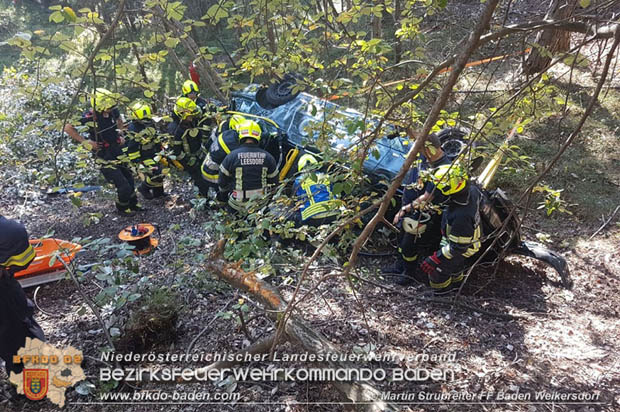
[293,172,342,222]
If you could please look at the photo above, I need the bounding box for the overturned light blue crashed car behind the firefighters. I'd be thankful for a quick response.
[225,78,571,288]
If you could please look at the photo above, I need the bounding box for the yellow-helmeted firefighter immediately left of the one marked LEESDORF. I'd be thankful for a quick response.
[200,114,246,189]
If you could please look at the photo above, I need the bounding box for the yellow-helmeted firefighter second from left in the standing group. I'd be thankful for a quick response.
[123,102,166,199]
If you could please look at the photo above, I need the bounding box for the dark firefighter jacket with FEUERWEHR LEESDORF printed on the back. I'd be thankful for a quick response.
[218,143,278,208]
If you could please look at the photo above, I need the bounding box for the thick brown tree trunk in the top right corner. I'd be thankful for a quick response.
[523,0,578,75]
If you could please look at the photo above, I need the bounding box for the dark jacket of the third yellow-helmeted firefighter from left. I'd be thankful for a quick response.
[168,120,204,167]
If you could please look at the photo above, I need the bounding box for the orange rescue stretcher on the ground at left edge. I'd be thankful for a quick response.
[15,238,82,288]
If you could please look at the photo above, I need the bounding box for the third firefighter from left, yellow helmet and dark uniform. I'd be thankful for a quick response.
[168,97,209,196]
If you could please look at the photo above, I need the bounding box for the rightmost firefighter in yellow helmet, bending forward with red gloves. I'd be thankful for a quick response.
[420,164,482,295]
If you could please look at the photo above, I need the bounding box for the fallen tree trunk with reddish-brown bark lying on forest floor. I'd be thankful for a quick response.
[194,240,400,412]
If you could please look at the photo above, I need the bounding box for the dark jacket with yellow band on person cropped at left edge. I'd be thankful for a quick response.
[0,216,35,272]
